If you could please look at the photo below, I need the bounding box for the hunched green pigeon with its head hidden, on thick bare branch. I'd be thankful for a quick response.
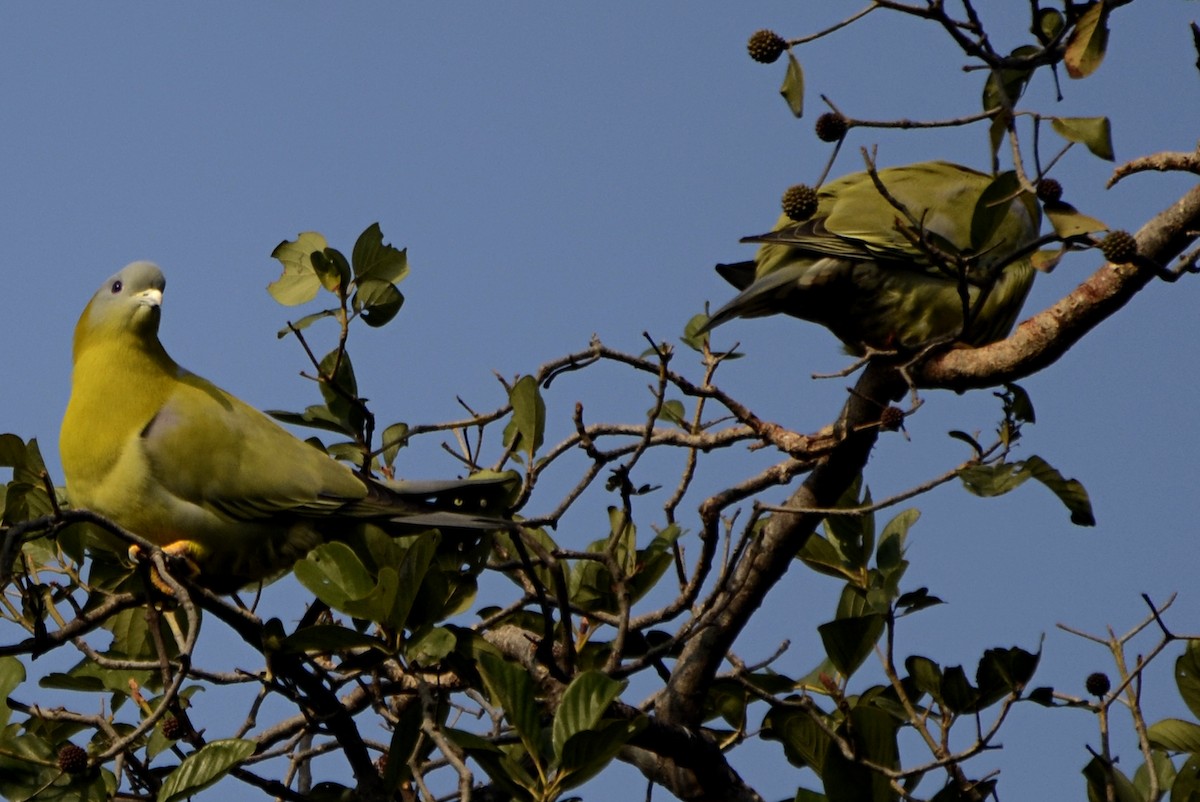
[702,161,1042,355]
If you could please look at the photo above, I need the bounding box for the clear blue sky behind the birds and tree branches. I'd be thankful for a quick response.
[0,6,1200,798]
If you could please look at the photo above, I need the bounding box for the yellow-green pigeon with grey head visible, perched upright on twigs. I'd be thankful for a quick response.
[59,262,511,593]
